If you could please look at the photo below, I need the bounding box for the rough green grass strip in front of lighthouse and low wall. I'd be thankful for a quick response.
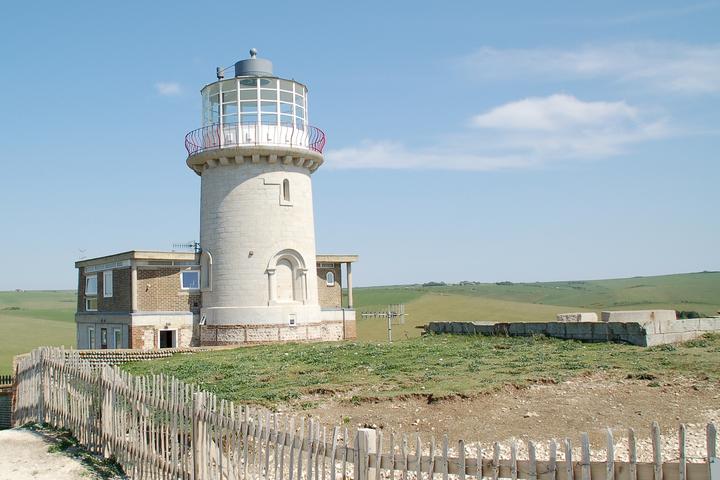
[123,335,720,407]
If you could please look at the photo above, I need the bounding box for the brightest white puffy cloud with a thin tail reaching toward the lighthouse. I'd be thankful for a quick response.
[326,94,671,171]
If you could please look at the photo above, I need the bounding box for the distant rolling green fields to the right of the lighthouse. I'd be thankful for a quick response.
[353,272,720,340]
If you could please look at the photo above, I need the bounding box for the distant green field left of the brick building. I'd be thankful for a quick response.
[0,290,77,374]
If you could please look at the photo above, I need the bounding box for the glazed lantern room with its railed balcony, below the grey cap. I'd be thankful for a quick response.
[185,77,325,161]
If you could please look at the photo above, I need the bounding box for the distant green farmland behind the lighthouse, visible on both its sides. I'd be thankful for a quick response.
[0,272,720,373]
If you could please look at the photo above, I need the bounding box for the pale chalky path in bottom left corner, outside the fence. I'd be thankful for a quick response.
[0,429,92,480]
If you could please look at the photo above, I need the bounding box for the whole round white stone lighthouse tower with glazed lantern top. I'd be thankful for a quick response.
[185,49,332,344]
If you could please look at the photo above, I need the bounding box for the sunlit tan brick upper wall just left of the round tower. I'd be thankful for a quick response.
[137,267,200,313]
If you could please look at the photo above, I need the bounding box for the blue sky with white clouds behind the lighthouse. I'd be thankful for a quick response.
[0,1,720,290]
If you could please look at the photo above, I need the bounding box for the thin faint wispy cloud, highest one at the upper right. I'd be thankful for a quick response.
[460,42,720,94]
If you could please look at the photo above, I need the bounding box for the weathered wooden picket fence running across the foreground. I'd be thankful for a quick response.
[14,347,720,480]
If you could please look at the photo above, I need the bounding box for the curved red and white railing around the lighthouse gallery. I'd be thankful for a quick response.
[185,123,325,155]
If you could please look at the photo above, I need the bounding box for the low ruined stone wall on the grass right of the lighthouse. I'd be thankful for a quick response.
[425,317,720,347]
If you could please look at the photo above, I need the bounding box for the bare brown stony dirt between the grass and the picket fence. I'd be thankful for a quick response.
[308,374,720,461]
